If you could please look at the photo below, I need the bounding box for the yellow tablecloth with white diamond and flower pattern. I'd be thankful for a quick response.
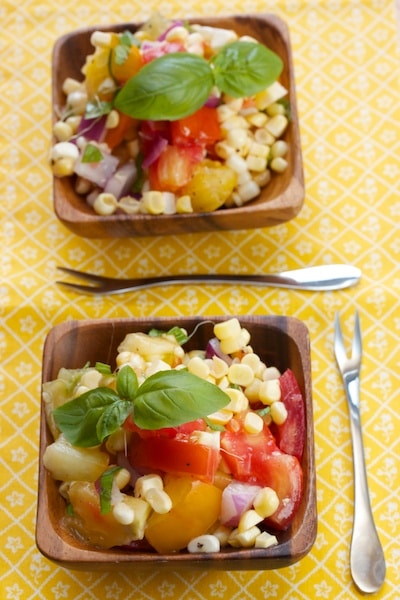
[0,0,400,600]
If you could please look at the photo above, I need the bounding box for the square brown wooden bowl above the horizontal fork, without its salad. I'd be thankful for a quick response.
[52,15,304,238]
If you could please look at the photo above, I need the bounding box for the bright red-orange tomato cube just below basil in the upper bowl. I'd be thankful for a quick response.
[171,106,222,146]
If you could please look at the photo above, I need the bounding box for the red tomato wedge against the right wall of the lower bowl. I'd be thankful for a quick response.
[272,369,306,460]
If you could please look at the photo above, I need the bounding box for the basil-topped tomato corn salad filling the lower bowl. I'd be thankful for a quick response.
[43,318,305,554]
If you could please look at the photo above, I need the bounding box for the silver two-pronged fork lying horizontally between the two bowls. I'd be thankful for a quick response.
[57,264,361,294]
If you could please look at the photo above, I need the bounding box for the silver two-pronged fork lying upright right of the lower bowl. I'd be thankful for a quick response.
[334,311,386,593]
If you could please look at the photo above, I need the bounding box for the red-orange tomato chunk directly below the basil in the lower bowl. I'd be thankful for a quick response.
[128,433,220,482]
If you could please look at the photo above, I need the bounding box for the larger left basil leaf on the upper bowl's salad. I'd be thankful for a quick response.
[114,52,214,121]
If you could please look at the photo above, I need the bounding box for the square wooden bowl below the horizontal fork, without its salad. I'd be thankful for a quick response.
[36,316,317,570]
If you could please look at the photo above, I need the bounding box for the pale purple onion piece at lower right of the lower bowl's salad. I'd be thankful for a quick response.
[220,480,262,527]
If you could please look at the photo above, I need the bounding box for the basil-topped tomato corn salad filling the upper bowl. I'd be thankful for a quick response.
[50,16,290,215]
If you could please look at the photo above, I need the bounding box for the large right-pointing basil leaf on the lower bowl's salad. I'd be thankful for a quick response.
[133,369,229,429]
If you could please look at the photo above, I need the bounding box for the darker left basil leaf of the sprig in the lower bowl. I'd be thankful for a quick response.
[53,387,119,448]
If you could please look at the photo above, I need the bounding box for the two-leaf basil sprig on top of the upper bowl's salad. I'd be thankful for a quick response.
[114,41,283,121]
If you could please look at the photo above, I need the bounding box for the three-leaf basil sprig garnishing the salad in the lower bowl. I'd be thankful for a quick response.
[53,365,229,448]
